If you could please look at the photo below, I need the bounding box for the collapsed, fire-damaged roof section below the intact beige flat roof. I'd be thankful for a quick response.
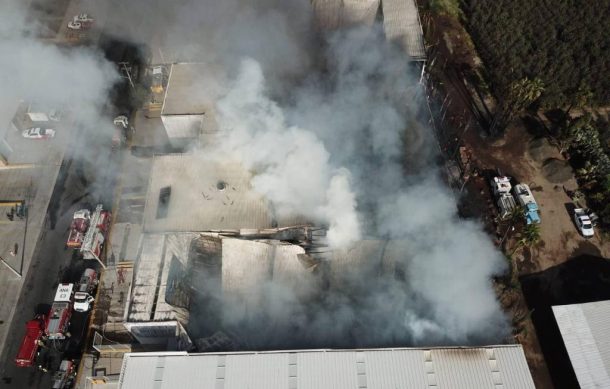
[119,231,317,350]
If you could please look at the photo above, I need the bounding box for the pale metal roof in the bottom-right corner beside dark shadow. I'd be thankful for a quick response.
[553,300,610,388]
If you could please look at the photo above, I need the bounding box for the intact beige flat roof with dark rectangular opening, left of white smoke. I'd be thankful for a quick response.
[144,154,304,232]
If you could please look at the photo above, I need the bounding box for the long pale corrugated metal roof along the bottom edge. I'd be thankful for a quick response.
[119,345,534,389]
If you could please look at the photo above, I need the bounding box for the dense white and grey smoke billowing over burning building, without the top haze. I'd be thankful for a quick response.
[198,41,506,348]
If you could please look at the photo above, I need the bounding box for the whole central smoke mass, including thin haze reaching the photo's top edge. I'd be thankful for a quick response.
[95,0,507,348]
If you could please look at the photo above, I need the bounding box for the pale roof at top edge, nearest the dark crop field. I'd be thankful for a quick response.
[381,0,426,60]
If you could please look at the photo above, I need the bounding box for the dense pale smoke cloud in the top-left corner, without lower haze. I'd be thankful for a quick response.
[0,0,116,133]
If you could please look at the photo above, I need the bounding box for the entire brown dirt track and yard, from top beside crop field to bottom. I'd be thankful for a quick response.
[422,6,610,388]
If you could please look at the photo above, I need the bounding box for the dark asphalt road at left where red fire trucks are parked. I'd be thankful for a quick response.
[0,134,118,389]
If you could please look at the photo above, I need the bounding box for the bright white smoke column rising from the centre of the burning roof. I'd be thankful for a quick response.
[209,59,360,247]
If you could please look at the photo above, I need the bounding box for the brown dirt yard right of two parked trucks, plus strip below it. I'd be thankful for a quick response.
[464,124,610,388]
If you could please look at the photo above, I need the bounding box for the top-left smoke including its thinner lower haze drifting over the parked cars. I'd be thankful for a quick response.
[0,0,118,205]
